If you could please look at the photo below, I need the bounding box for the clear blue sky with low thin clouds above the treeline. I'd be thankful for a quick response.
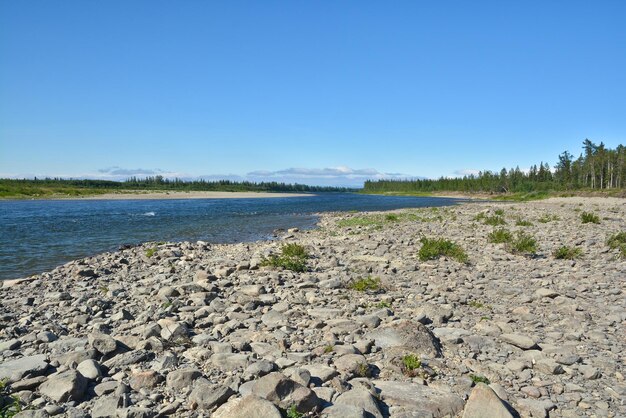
[0,0,626,184]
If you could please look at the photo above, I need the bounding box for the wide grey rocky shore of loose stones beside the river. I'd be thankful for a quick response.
[0,198,626,418]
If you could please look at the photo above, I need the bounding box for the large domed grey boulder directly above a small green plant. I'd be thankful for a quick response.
[366,320,441,357]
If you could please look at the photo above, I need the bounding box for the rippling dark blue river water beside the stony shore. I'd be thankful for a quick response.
[0,193,459,280]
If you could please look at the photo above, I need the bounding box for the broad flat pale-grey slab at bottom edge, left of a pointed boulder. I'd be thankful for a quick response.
[372,380,465,418]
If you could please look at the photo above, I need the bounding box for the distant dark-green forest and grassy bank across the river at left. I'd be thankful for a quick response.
[0,176,354,198]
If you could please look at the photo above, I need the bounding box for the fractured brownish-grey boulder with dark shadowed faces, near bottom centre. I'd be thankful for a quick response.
[252,372,319,413]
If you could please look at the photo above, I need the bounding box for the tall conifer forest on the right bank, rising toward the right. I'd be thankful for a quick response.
[363,139,626,193]
